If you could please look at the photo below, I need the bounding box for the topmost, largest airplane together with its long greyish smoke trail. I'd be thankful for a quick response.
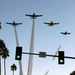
[25,13,42,75]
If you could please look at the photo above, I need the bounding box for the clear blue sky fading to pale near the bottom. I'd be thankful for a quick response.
[0,0,75,75]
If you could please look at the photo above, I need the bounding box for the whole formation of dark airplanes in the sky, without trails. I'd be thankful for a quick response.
[0,13,71,35]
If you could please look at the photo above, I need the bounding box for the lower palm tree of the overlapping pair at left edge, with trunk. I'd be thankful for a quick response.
[1,47,9,75]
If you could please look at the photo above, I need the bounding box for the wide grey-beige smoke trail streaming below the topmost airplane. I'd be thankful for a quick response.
[27,18,35,75]
